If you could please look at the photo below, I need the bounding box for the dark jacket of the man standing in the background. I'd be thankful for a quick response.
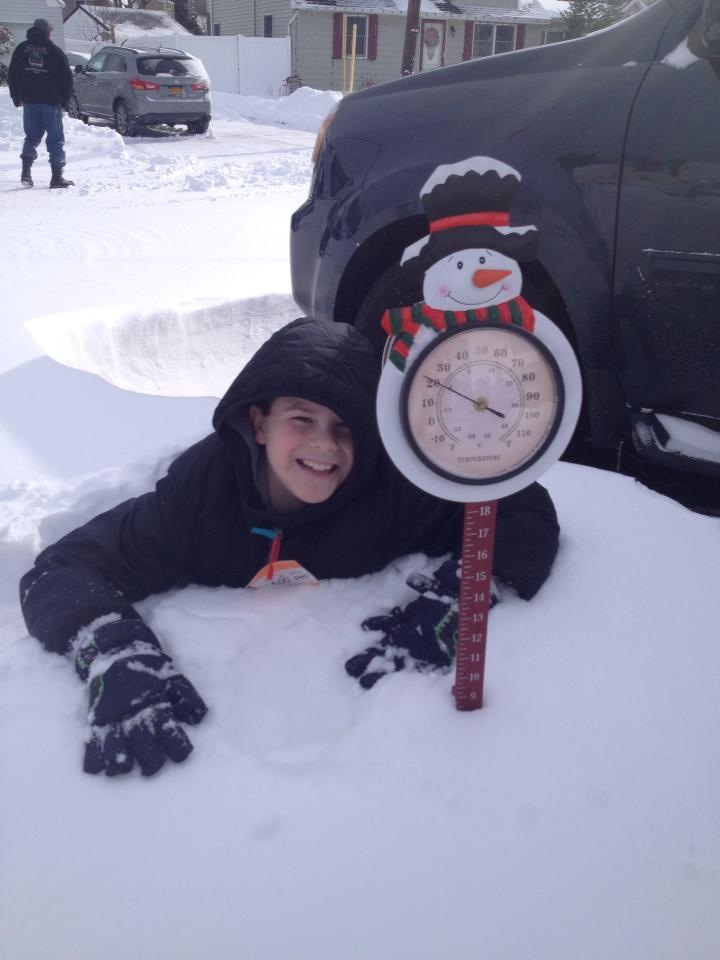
[8,27,73,109]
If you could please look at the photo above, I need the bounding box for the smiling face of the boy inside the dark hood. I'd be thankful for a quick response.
[250,397,353,513]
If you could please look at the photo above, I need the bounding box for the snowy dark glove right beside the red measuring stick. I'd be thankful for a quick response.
[345,556,500,690]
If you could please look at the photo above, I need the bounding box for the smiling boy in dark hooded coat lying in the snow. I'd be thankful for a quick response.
[21,319,558,775]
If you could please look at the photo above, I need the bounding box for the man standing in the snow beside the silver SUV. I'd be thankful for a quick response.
[8,18,74,188]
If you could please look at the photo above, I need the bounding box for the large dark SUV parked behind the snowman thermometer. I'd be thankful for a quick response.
[291,0,720,476]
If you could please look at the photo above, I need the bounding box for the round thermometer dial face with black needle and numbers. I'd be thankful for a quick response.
[400,323,565,484]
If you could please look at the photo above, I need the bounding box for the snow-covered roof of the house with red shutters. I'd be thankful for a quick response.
[290,0,560,23]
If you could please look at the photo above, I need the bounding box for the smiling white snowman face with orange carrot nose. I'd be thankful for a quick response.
[423,249,522,310]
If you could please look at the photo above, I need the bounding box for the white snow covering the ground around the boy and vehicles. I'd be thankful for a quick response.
[0,90,720,960]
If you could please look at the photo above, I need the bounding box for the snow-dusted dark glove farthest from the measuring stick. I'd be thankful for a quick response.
[74,619,207,777]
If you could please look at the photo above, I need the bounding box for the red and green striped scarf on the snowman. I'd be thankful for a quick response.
[381,297,535,371]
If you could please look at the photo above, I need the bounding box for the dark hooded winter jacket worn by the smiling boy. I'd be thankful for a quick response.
[21,319,558,653]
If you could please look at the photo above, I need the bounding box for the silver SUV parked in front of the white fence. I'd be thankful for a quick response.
[68,47,210,137]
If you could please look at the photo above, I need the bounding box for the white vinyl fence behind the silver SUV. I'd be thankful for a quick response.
[65,33,290,97]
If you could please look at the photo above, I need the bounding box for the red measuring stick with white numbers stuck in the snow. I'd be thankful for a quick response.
[453,500,497,710]
